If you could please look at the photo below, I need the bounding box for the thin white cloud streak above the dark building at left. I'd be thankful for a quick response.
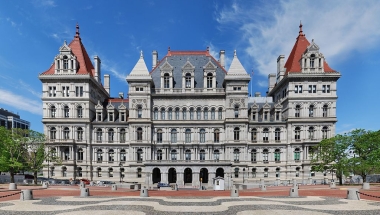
[0,89,42,115]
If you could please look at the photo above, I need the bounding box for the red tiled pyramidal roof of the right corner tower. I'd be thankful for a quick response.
[285,24,335,74]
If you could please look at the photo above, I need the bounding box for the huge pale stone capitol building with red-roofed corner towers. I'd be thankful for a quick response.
[39,25,340,186]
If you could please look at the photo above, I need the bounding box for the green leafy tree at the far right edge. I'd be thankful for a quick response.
[349,129,380,182]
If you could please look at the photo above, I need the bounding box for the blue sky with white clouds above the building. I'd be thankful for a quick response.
[0,0,380,133]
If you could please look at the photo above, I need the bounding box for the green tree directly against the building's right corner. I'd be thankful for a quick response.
[311,134,350,184]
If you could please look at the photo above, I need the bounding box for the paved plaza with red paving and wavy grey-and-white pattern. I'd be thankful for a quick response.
[0,184,380,215]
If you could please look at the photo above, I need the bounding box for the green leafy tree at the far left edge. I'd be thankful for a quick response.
[0,126,27,183]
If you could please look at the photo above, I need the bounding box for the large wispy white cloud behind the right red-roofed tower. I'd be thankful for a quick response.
[216,0,380,76]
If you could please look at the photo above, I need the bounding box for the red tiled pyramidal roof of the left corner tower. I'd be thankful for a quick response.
[42,24,94,76]
